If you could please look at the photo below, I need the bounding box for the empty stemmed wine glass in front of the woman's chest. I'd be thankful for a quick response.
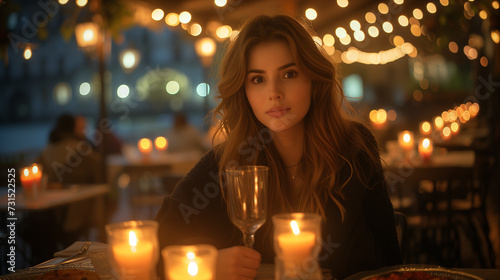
[226,165,269,248]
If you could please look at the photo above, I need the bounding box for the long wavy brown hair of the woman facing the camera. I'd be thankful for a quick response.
[212,15,378,221]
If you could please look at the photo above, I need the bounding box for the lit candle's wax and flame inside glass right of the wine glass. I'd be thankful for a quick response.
[278,220,316,270]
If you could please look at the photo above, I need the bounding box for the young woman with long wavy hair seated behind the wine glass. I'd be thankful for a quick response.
[157,16,401,279]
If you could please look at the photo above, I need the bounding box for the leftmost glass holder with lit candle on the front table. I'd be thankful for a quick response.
[106,221,159,280]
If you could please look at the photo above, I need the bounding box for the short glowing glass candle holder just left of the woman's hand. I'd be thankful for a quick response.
[161,244,217,280]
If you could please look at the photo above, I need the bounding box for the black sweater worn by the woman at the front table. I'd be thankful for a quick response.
[156,128,401,279]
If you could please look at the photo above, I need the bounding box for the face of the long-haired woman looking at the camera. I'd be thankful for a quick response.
[244,41,311,133]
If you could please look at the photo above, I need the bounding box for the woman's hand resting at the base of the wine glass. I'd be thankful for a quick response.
[216,246,261,280]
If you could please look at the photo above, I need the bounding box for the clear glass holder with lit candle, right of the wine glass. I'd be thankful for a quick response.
[272,213,322,280]
